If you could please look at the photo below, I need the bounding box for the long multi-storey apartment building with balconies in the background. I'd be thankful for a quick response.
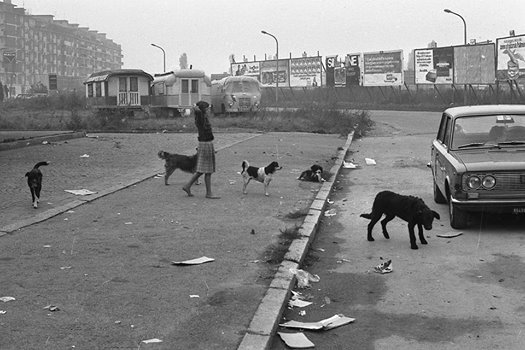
[0,0,123,97]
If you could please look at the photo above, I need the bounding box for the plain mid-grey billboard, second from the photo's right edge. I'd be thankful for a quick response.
[454,43,496,84]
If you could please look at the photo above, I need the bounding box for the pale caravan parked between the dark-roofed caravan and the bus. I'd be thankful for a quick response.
[151,69,211,114]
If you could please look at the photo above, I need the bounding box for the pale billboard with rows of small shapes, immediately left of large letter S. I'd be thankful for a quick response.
[288,57,322,87]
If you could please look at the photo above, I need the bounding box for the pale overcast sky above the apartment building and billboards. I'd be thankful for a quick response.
[12,0,525,75]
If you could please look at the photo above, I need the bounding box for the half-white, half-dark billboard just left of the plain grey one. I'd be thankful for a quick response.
[414,47,454,84]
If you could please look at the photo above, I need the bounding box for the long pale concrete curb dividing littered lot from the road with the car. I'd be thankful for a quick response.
[237,132,354,350]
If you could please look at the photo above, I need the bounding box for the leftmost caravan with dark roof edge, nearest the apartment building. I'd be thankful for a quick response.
[84,69,153,109]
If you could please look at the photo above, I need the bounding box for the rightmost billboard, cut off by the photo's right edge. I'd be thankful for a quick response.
[496,35,525,82]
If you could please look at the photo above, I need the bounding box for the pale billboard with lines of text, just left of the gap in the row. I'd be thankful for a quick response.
[363,50,403,86]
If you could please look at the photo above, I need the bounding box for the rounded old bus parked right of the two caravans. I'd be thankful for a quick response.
[211,76,261,114]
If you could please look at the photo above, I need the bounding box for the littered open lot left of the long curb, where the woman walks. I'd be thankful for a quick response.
[0,133,346,350]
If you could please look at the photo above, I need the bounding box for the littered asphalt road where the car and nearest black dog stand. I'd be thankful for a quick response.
[271,111,525,350]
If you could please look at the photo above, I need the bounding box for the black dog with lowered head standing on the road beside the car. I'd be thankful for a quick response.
[361,191,439,249]
